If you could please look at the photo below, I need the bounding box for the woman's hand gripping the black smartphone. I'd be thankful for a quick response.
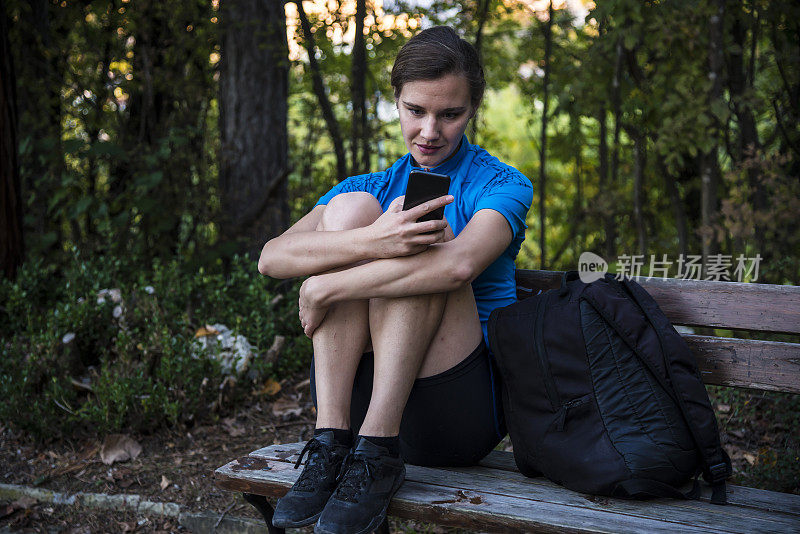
[367,195,454,258]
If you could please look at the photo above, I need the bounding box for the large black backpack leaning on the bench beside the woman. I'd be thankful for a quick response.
[489,271,731,504]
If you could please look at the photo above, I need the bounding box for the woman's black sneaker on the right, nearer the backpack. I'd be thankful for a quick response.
[314,436,406,534]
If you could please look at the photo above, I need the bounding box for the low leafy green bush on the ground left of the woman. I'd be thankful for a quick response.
[0,252,311,438]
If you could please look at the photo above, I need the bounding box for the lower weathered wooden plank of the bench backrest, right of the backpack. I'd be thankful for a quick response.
[683,335,800,393]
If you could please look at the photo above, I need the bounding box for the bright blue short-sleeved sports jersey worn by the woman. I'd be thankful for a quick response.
[317,136,533,344]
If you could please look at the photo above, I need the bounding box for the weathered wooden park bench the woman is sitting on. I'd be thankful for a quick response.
[215,270,800,533]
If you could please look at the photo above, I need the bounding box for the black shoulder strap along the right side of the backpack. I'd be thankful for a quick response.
[615,278,732,504]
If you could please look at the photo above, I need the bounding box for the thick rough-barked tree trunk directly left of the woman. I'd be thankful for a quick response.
[219,0,289,255]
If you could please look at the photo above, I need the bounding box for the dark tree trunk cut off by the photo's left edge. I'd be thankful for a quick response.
[0,0,25,279]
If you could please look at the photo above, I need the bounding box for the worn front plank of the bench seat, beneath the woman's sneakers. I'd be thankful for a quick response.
[216,450,800,532]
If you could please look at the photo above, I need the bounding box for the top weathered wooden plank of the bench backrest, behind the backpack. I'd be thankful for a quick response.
[517,269,800,334]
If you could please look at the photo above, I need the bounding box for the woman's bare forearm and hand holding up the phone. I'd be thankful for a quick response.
[258,195,453,278]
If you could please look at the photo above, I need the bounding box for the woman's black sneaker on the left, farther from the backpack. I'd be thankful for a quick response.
[272,431,350,528]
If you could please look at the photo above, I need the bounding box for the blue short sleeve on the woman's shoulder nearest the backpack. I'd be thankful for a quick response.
[475,167,533,236]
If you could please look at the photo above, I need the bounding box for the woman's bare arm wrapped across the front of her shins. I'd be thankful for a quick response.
[300,209,513,336]
